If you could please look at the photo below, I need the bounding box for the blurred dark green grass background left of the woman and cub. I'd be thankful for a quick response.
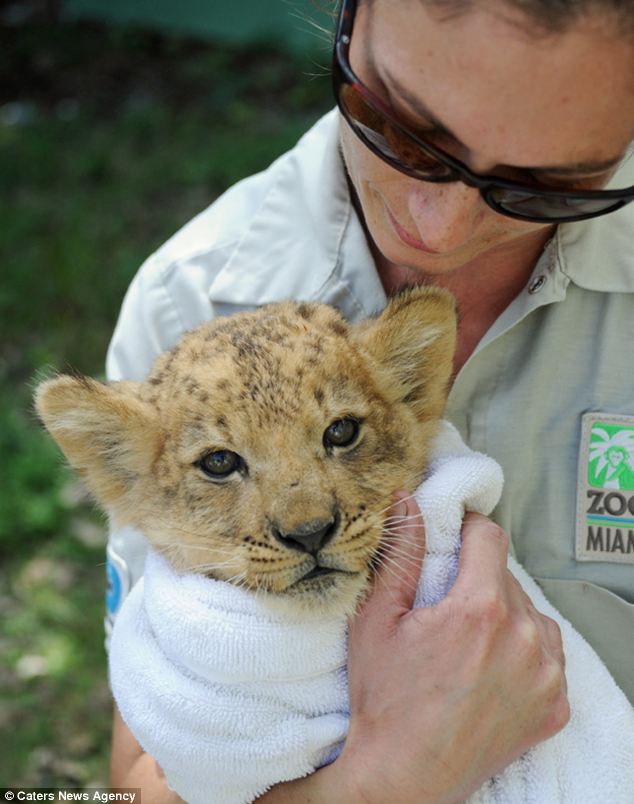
[0,0,332,787]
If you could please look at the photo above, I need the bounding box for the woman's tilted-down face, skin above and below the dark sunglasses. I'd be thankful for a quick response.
[341,0,634,275]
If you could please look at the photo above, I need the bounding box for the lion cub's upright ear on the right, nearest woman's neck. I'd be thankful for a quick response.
[357,287,456,419]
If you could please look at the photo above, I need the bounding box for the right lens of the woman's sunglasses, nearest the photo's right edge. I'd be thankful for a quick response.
[487,188,622,221]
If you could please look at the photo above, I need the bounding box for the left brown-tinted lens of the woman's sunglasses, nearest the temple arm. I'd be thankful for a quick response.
[337,83,451,181]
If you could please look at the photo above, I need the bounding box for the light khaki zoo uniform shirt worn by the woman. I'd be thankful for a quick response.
[108,111,634,701]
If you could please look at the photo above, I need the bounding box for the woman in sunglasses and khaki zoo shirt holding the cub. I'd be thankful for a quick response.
[109,0,634,804]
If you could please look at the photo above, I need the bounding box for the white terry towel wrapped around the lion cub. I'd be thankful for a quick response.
[110,426,634,804]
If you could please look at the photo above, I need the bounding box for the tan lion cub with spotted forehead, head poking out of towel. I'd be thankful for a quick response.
[36,288,456,613]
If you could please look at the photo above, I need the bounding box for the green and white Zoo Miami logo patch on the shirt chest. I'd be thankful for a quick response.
[575,413,634,564]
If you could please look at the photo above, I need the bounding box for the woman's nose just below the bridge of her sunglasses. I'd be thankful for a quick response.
[408,181,484,253]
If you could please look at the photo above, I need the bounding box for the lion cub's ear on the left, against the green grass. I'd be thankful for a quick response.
[35,376,161,510]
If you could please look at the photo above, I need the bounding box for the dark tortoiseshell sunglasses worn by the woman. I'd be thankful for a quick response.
[333,0,634,223]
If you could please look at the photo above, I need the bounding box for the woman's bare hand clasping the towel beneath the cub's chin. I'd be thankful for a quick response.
[335,496,569,804]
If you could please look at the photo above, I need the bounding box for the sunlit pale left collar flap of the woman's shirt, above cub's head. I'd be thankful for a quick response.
[209,109,385,320]
